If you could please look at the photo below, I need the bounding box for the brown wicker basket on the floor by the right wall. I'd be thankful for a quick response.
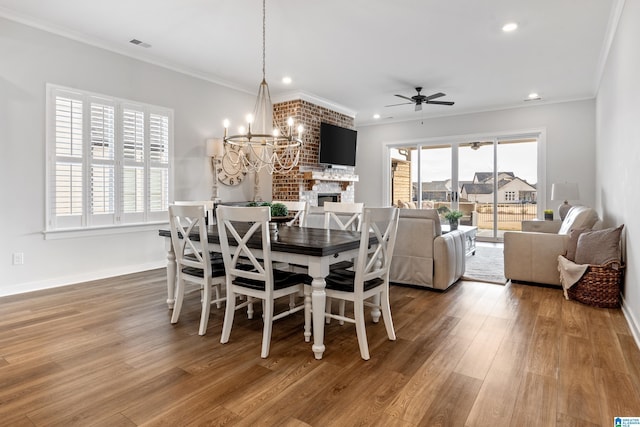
[567,261,624,308]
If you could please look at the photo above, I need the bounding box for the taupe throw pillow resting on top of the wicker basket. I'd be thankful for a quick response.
[575,224,624,265]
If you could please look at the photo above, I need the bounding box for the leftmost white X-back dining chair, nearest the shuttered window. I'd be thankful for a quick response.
[169,204,225,335]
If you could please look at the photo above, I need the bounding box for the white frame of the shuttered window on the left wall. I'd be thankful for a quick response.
[45,84,174,238]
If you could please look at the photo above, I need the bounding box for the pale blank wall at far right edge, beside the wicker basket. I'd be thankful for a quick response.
[596,0,640,343]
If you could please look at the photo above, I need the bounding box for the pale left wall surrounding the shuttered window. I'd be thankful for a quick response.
[0,18,260,295]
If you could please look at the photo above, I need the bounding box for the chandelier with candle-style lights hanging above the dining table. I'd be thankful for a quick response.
[222,0,304,174]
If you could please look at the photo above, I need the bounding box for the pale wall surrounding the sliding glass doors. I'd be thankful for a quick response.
[356,96,595,209]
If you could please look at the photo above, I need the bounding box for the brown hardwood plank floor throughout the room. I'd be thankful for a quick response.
[0,270,640,427]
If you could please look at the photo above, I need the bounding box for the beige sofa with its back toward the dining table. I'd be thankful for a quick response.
[389,209,465,290]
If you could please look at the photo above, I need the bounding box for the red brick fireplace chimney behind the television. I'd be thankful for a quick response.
[271,99,354,205]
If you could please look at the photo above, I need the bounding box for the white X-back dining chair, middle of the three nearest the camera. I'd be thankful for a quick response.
[216,206,310,358]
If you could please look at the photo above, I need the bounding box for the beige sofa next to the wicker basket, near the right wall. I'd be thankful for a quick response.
[504,206,601,286]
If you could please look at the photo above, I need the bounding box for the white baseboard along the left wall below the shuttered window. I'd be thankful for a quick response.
[0,261,167,297]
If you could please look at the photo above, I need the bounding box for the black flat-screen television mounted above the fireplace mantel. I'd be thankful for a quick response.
[319,123,358,166]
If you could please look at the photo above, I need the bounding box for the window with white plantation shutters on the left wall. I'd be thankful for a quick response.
[47,85,173,231]
